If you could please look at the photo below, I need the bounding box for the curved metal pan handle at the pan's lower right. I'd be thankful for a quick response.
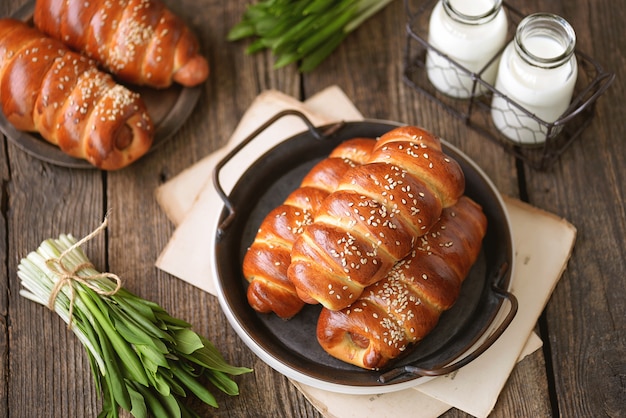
[378,262,518,384]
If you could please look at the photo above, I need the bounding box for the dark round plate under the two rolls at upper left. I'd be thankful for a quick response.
[0,0,202,169]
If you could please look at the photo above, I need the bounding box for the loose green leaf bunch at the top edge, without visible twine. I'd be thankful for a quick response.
[228,0,392,73]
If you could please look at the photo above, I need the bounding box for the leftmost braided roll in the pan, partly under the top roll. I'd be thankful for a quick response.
[243,138,376,319]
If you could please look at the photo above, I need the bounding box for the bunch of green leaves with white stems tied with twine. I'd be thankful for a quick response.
[17,219,252,418]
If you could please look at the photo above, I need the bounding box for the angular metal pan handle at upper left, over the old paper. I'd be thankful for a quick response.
[213,109,344,239]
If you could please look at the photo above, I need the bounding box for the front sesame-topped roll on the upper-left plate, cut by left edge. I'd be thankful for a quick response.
[0,19,153,170]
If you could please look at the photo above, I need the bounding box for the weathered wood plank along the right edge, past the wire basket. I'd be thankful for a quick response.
[516,1,626,417]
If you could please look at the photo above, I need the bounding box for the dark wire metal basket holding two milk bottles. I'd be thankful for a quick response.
[403,0,615,170]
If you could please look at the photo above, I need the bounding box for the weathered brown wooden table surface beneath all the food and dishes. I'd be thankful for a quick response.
[0,0,626,417]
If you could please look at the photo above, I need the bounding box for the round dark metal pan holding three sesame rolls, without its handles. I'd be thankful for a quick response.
[211,116,513,394]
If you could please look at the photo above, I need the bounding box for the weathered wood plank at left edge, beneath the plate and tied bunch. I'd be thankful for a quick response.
[7,149,104,417]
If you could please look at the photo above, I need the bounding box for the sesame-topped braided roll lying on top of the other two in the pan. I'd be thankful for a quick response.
[288,126,465,310]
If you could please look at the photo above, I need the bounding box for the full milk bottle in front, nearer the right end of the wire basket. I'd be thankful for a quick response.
[491,13,578,144]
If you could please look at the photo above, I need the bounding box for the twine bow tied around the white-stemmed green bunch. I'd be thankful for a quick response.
[46,217,122,328]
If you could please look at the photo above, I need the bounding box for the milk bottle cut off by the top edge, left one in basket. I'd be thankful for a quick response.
[426,0,508,98]
